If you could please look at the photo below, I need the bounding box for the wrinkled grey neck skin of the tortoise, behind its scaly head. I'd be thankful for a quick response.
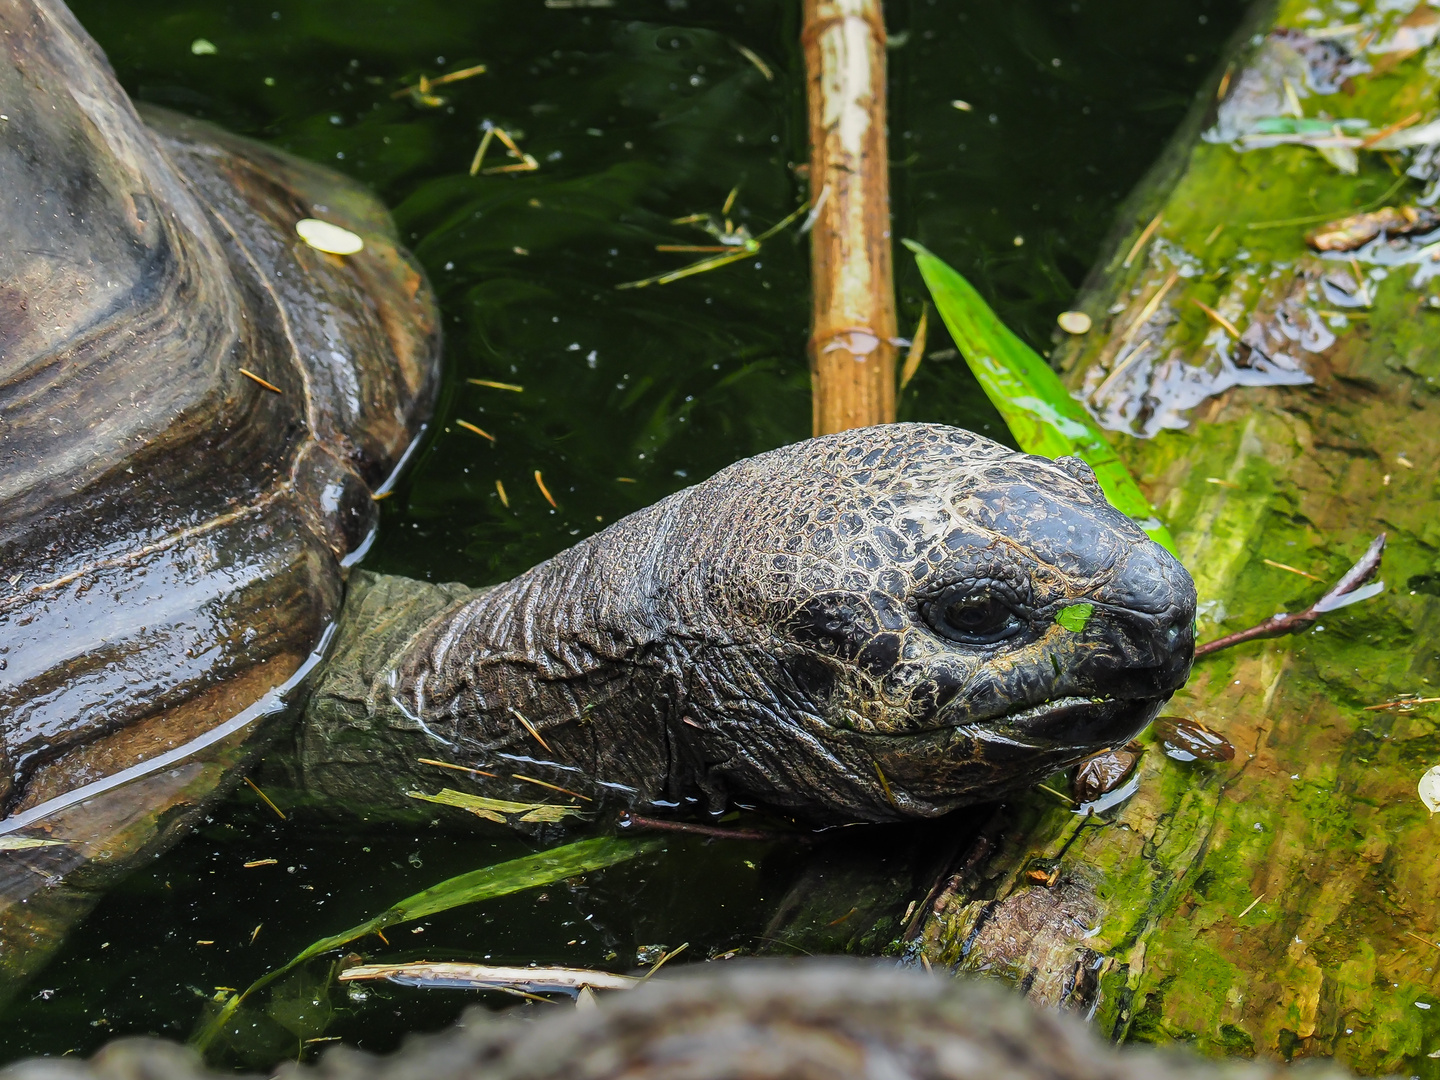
[372,490,776,809]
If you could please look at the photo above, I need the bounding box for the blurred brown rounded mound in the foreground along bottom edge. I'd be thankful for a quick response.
[0,959,1344,1080]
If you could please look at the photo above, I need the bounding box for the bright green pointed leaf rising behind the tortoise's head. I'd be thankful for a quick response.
[904,240,1175,553]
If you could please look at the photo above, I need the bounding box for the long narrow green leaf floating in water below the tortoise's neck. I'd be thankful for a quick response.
[193,837,661,1053]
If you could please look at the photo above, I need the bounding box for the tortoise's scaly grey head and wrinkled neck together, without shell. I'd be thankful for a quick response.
[311,423,1195,821]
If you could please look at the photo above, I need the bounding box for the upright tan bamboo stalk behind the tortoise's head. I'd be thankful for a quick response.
[801,0,897,435]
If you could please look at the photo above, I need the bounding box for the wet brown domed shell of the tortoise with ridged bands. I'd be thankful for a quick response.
[0,0,439,979]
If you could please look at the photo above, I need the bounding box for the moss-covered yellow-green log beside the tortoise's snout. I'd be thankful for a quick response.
[913,0,1440,1077]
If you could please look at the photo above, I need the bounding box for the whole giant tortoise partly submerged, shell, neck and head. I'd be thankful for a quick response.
[0,0,1195,996]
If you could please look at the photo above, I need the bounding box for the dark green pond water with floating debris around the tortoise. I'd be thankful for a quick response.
[0,0,1243,1067]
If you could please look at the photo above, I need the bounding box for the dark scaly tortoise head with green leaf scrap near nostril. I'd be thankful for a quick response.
[675,423,1195,818]
